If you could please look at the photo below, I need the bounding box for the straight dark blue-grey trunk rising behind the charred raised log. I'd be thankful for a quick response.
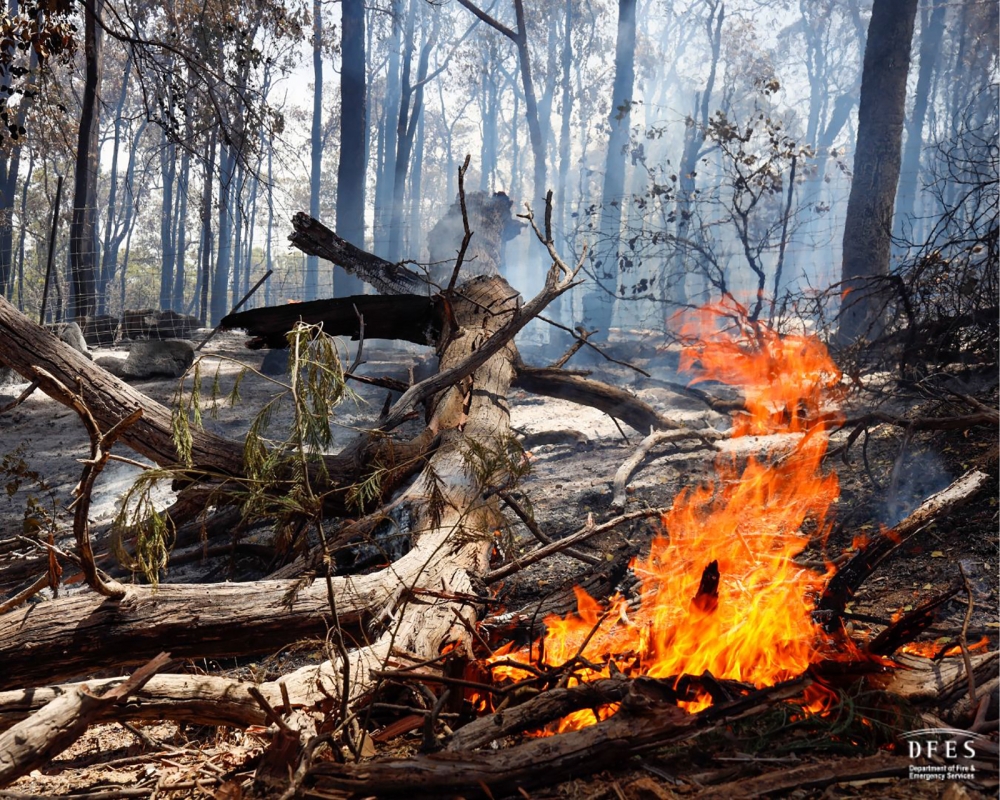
[336,0,368,297]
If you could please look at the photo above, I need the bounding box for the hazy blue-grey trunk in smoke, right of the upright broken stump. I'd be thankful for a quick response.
[583,0,636,337]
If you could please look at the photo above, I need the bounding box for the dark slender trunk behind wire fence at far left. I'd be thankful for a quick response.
[69,0,104,317]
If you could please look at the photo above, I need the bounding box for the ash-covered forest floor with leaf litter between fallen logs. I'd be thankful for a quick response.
[0,333,1000,800]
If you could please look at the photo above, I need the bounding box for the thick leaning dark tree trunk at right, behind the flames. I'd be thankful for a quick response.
[838,0,917,343]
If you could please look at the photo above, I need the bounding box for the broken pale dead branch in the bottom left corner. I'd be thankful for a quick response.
[0,653,170,787]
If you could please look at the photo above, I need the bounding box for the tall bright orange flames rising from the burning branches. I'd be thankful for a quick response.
[492,300,840,730]
